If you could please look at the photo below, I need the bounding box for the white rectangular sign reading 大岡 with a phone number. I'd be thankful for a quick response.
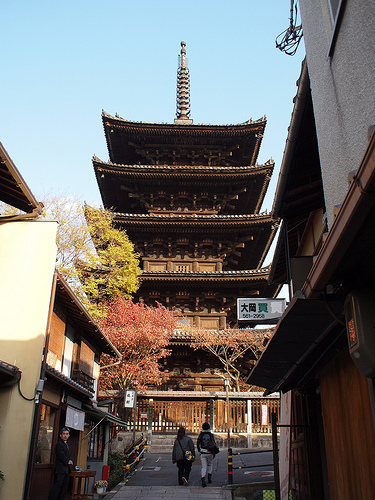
[237,298,286,323]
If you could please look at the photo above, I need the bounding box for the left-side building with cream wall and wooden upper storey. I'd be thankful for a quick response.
[0,143,124,500]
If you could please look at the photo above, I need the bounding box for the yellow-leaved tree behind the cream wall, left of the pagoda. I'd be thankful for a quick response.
[0,195,141,319]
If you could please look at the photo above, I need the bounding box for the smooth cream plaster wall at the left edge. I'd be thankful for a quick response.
[0,221,57,500]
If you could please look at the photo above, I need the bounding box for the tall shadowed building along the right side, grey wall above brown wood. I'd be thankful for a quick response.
[250,0,375,500]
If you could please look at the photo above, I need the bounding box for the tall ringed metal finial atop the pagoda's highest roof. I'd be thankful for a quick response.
[174,42,193,125]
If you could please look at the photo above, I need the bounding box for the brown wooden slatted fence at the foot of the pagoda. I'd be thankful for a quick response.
[129,397,280,434]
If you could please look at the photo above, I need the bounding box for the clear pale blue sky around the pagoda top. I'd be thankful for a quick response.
[0,0,304,210]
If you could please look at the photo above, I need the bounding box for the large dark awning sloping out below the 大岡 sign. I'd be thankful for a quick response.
[248,296,343,393]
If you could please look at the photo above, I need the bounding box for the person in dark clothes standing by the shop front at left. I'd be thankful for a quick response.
[48,427,73,500]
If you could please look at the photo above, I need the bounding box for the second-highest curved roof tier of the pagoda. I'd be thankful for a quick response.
[93,158,274,213]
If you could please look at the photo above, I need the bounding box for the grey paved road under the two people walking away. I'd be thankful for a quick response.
[101,450,273,500]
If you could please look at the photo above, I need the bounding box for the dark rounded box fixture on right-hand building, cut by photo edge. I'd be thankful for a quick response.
[345,290,375,378]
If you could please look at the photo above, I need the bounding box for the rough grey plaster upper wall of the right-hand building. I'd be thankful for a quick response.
[299,0,375,227]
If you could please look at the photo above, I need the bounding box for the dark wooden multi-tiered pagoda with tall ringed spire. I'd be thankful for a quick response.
[93,42,278,336]
